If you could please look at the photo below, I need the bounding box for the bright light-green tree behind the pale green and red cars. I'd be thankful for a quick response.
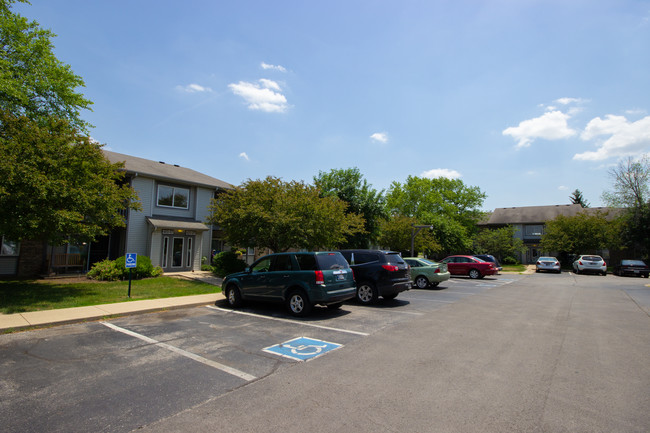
[386,176,485,254]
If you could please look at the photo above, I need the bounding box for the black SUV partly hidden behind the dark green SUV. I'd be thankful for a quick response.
[339,250,411,304]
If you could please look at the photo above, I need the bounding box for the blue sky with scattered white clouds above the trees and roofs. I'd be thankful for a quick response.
[13,0,650,211]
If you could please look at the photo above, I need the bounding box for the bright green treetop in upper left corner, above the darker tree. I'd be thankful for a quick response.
[0,0,92,132]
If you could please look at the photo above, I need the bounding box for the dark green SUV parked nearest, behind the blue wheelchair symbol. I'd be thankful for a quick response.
[221,251,356,316]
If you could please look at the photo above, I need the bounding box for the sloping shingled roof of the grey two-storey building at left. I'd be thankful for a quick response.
[102,149,234,189]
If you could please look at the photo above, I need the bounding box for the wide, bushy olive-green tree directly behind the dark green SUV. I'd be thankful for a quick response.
[209,176,363,252]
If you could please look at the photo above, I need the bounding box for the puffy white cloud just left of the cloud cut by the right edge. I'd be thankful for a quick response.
[502,111,576,148]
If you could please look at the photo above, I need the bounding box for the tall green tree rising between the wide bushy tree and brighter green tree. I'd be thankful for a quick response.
[314,167,387,248]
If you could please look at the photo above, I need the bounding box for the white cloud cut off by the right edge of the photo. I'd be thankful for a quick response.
[573,114,650,161]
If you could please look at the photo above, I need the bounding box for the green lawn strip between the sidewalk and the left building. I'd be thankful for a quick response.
[0,277,221,314]
